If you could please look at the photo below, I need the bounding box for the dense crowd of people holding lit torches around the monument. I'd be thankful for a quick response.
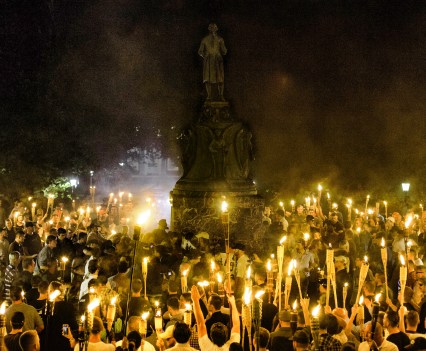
[0,195,426,351]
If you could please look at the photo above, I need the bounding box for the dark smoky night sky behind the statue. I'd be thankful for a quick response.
[0,0,426,201]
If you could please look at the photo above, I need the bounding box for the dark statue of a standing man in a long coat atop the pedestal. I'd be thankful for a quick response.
[198,23,227,101]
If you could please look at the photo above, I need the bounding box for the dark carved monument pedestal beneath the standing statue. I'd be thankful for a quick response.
[171,101,264,246]
